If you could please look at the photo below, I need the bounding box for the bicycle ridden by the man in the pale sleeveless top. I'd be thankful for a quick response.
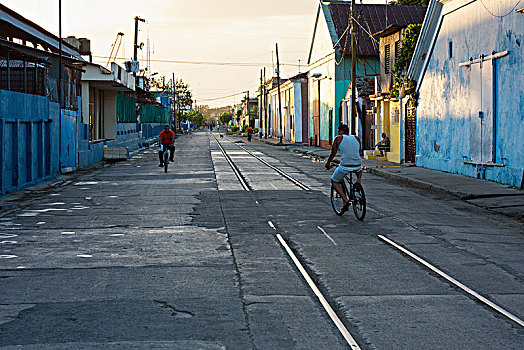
[331,172,366,221]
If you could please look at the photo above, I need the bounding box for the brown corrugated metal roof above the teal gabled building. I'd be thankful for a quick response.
[327,2,427,56]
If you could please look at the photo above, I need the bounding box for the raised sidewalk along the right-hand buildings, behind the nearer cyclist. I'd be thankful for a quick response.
[254,134,524,220]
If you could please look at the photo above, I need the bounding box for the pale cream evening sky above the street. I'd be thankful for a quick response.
[1,0,385,107]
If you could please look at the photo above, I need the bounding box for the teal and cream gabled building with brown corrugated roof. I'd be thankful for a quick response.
[308,2,424,148]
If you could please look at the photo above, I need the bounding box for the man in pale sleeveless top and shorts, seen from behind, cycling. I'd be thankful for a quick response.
[326,124,362,211]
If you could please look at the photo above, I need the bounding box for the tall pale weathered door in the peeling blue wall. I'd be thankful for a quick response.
[470,60,494,163]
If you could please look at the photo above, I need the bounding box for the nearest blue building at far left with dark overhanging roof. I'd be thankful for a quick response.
[0,5,84,194]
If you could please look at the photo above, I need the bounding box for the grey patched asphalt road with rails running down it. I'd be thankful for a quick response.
[0,132,524,349]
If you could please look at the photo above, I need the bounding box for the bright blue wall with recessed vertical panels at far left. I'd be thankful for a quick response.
[0,90,60,194]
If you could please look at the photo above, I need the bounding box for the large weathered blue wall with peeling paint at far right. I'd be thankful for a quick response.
[416,0,524,186]
